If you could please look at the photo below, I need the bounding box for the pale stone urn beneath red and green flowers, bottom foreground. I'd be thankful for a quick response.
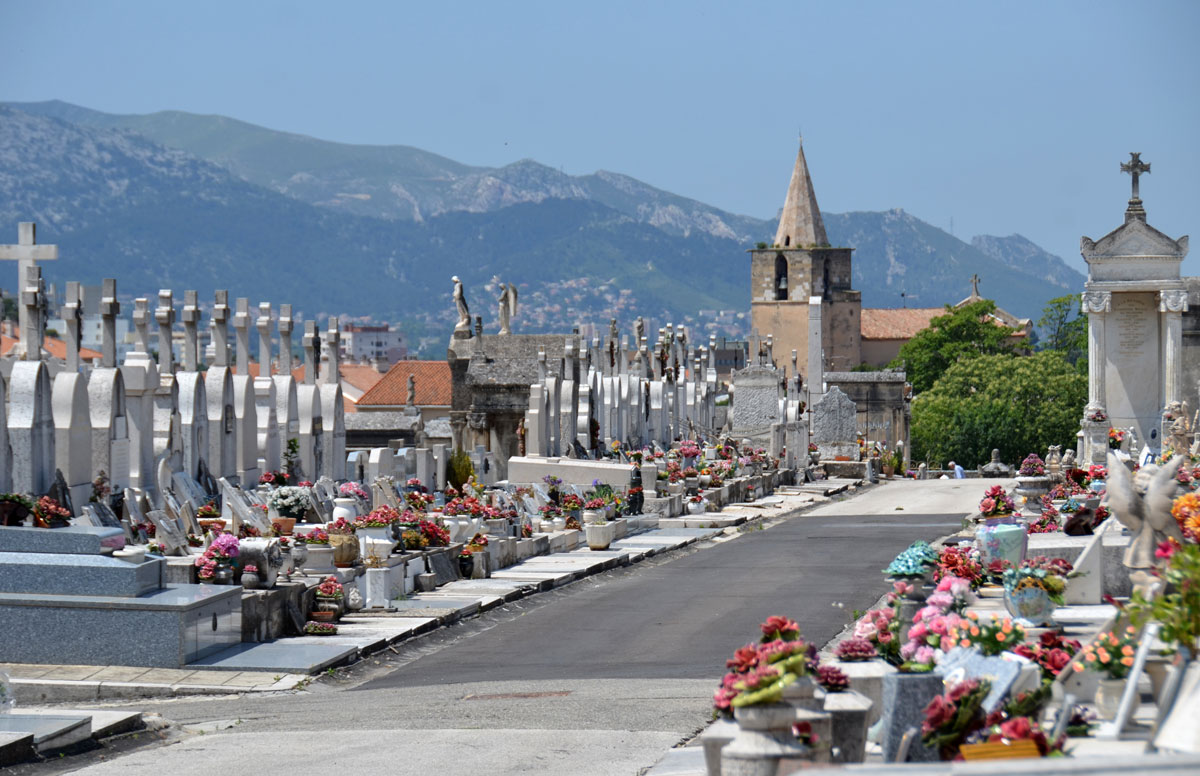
[721,703,814,776]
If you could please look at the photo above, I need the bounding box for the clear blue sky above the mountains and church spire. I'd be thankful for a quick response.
[0,0,1200,275]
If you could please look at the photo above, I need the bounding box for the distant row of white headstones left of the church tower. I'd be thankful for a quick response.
[526,327,718,457]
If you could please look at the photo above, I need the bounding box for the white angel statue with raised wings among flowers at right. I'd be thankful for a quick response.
[1105,451,1183,595]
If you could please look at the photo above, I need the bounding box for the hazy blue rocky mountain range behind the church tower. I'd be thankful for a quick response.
[0,101,1084,352]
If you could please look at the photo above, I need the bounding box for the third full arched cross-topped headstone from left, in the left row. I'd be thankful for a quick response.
[88,278,130,493]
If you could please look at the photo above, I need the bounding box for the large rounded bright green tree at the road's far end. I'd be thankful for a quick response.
[912,350,1087,465]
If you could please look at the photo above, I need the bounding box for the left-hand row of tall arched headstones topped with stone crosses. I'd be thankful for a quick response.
[0,265,346,504]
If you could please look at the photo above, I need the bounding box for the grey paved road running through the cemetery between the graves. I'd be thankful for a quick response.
[58,481,980,776]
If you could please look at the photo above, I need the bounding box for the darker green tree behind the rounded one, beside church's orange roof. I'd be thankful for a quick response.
[888,299,1014,393]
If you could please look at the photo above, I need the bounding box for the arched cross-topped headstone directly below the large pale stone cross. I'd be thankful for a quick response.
[8,266,55,497]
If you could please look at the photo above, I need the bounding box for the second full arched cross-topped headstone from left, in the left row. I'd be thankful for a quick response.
[50,281,92,504]
